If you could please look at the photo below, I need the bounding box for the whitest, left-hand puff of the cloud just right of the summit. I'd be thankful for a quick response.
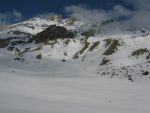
[65,5,109,24]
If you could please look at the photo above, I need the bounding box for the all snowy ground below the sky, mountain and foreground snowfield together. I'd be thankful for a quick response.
[0,17,150,113]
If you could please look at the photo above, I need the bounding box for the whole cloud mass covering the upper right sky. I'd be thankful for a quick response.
[65,0,150,34]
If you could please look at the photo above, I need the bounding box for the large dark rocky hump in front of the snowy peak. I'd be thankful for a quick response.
[30,25,75,43]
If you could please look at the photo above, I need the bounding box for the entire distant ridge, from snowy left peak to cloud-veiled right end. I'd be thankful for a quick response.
[0,15,150,39]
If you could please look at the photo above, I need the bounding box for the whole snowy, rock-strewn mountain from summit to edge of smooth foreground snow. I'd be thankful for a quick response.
[0,17,150,81]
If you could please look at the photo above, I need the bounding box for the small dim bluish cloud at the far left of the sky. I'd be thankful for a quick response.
[0,9,23,24]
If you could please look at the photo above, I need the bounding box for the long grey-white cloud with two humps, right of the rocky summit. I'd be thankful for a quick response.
[65,5,132,24]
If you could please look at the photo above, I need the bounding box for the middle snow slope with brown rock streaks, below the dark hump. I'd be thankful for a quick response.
[1,36,150,81]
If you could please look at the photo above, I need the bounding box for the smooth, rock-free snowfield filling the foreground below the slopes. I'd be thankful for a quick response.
[0,58,150,113]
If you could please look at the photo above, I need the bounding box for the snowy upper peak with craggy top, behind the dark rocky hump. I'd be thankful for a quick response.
[0,18,83,38]
